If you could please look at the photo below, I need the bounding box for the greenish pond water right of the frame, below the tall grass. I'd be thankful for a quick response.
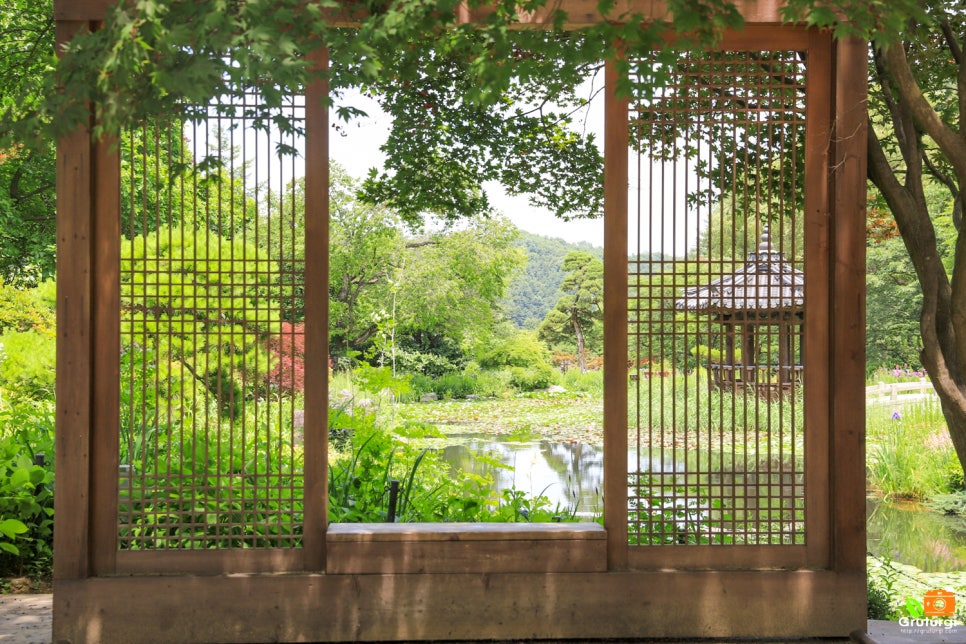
[866,498,966,572]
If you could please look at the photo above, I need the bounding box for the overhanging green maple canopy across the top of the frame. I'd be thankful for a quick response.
[13,0,919,226]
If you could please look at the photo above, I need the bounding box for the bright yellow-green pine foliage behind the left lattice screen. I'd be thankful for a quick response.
[121,227,279,417]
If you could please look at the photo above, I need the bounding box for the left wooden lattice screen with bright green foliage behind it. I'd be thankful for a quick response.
[118,98,305,550]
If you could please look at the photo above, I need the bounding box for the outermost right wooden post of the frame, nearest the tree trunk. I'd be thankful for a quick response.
[830,38,868,574]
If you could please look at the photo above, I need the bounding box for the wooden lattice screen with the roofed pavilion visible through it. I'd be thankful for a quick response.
[628,52,806,546]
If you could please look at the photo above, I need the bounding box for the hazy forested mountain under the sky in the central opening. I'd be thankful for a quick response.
[504,231,604,329]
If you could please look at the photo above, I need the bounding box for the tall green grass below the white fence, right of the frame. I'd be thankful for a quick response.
[866,398,963,500]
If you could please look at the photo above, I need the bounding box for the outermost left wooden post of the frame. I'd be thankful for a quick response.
[54,21,93,587]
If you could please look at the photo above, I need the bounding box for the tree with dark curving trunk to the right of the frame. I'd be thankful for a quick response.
[868,0,966,464]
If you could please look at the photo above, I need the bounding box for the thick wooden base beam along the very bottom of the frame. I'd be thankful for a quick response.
[54,570,866,644]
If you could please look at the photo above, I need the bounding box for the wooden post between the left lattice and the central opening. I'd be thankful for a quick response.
[302,50,329,570]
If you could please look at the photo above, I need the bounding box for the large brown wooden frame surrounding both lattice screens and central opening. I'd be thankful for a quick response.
[54,0,866,642]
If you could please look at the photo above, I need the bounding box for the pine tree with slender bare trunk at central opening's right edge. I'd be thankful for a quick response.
[537,251,604,373]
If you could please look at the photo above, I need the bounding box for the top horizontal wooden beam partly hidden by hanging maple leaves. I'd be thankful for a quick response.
[54,0,782,28]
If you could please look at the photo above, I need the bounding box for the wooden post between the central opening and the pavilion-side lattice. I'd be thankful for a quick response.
[604,54,630,569]
